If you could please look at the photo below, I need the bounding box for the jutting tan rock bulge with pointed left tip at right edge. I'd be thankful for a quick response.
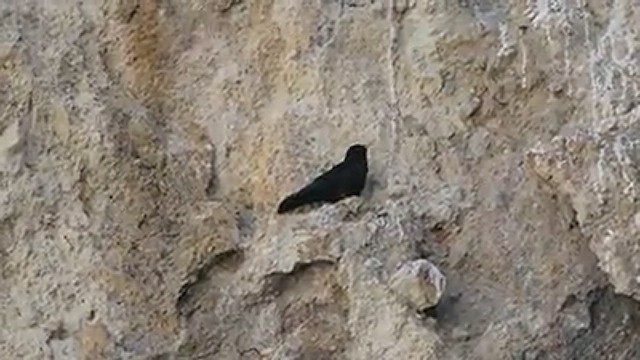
[529,119,640,301]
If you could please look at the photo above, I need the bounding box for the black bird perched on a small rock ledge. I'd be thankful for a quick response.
[278,144,368,214]
